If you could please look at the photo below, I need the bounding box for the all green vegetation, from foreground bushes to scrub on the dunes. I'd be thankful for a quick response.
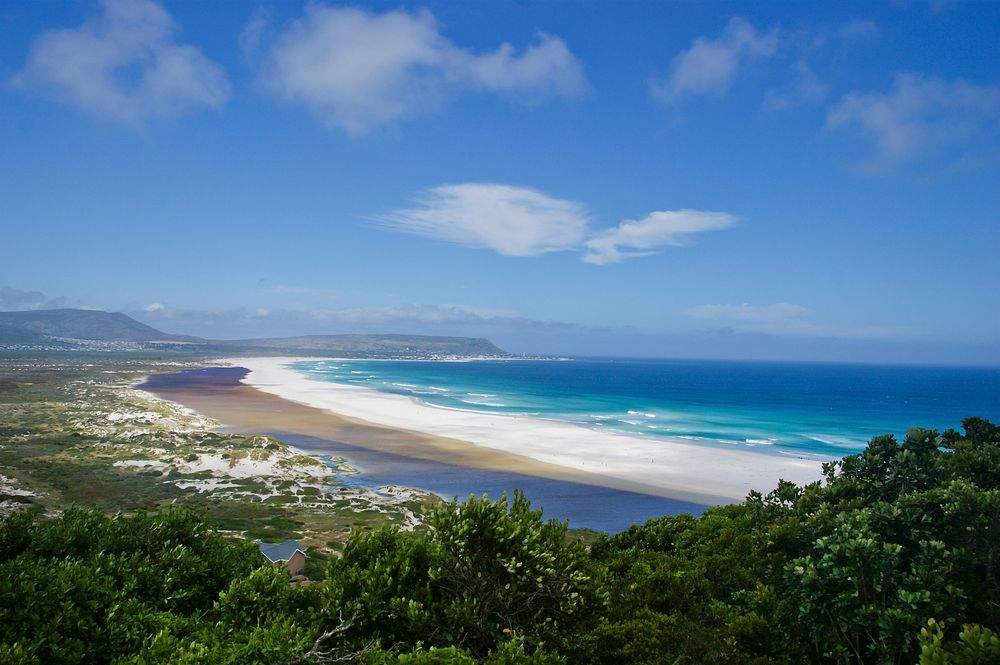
[0,350,1000,665]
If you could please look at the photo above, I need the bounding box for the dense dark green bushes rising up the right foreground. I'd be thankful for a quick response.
[590,418,1000,664]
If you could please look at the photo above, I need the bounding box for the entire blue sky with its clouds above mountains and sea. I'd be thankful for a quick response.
[0,0,1000,364]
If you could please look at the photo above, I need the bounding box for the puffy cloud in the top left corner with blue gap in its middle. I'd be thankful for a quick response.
[13,0,229,125]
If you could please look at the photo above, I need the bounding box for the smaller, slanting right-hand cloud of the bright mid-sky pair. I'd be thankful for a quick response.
[583,210,736,265]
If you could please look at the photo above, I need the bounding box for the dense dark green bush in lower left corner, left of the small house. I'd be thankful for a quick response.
[0,509,261,663]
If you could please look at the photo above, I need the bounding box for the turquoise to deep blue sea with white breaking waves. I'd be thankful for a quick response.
[293,359,1000,458]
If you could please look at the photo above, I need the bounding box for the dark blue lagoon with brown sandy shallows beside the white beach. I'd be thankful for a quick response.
[138,367,708,531]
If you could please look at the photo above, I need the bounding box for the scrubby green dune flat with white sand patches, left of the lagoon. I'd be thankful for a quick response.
[0,353,440,548]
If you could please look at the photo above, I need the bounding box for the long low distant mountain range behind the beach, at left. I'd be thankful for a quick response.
[0,309,509,358]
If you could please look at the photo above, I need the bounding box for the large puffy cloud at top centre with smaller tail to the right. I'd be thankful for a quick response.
[254,4,587,135]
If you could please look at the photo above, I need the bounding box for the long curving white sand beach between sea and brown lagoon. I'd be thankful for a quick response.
[224,357,822,502]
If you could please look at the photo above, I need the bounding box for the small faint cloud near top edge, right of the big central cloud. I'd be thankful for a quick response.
[652,17,778,102]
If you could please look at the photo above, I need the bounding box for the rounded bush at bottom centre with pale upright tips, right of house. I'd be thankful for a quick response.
[327,492,601,656]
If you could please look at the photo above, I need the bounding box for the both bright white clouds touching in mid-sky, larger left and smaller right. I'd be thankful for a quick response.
[372,183,736,265]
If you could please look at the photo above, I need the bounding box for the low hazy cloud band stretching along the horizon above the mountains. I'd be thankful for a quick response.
[0,287,968,359]
